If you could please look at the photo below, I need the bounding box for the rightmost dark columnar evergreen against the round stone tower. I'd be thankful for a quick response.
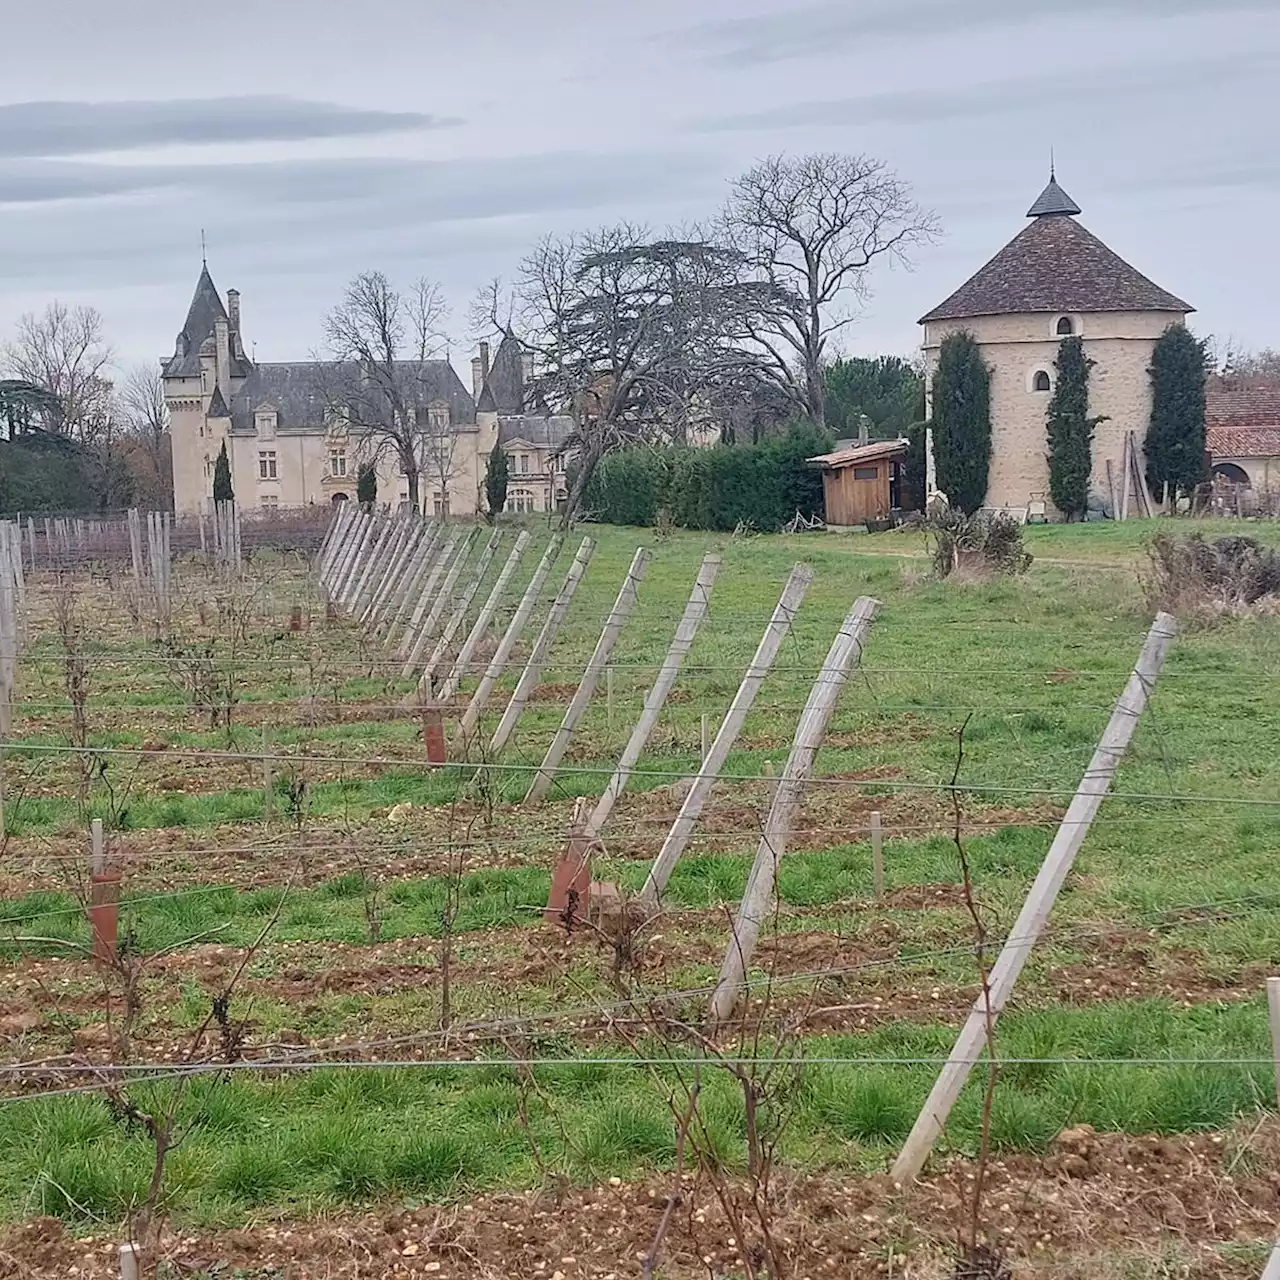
[1146,324,1207,500]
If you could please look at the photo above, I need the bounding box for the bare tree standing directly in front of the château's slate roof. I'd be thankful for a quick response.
[317,271,452,511]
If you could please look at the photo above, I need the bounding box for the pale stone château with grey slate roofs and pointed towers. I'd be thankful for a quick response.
[160,265,571,516]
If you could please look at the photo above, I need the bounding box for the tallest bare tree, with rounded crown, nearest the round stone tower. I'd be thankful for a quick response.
[721,154,938,426]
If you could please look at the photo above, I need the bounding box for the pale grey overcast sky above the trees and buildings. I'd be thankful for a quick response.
[0,0,1280,367]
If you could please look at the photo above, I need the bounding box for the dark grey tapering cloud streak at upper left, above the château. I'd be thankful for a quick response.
[0,95,462,157]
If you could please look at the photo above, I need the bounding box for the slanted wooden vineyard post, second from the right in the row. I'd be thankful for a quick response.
[710,595,879,1024]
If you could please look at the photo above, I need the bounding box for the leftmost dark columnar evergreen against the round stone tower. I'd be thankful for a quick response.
[933,332,991,513]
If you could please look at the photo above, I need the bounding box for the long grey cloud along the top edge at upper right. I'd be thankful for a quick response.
[675,0,1275,67]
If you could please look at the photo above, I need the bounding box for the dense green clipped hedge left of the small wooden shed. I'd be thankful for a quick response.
[585,428,832,531]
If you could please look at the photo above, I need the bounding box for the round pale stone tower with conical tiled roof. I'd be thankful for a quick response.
[920,174,1192,511]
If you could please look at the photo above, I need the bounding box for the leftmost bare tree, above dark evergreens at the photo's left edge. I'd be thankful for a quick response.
[3,301,114,444]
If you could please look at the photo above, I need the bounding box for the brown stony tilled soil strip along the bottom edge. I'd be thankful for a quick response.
[0,1117,1280,1280]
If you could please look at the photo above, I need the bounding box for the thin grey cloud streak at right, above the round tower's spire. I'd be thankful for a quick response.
[694,54,1280,132]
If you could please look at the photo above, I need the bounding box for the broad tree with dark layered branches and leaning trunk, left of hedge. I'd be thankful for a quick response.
[477,230,756,527]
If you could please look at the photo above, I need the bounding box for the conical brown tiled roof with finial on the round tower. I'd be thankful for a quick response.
[920,178,1194,324]
